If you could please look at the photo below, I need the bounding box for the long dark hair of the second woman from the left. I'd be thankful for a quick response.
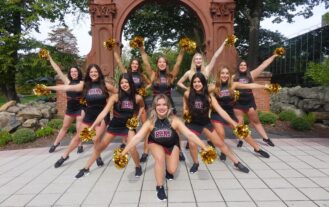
[83,64,109,98]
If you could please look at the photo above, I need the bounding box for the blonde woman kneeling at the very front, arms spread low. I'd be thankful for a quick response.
[122,94,207,200]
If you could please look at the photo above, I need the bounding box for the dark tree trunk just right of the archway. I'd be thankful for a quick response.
[247,0,262,69]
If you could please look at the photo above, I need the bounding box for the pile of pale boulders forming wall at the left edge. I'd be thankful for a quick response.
[0,101,57,132]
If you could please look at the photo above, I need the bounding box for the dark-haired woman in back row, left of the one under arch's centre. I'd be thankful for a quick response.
[114,47,151,162]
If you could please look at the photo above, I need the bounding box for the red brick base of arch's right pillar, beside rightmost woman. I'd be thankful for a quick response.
[253,71,272,111]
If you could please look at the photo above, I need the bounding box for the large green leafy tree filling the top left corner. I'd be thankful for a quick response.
[0,0,87,101]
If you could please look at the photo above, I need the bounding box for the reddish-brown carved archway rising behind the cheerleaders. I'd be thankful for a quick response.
[87,0,236,76]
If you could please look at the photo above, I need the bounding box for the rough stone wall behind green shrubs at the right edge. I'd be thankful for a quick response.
[270,86,329,123]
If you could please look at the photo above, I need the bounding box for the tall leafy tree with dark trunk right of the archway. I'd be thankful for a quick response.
[235,0,329,68]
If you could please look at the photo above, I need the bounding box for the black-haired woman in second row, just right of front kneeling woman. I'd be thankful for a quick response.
[183,73,249,173]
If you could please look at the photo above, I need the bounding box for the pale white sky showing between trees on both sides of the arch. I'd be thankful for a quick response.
[31,3,329,56]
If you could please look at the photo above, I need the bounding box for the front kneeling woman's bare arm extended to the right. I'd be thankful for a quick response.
[172,117,207,150]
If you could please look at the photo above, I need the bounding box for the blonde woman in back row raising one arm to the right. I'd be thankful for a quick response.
[177,40,225,90]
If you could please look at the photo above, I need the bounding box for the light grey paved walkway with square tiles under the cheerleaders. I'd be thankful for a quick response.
[0,138,329,207]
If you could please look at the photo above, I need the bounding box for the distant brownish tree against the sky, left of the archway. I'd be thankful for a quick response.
[48,27,79,55]
